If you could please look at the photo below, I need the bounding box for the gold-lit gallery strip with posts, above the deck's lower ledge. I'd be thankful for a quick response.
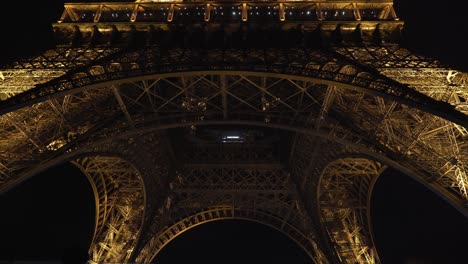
[58,0,398,23]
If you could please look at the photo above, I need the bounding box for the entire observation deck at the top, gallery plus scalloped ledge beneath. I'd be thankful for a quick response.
[53,0,403,46]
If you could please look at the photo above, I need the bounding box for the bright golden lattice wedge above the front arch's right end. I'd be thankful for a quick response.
[335,45,468,114]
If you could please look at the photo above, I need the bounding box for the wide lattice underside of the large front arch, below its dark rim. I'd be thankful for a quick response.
[2,68,466,262]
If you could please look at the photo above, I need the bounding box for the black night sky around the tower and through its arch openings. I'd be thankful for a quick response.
[0,0,468,264]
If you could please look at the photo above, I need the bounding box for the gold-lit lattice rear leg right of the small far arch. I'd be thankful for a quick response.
[291,136,385,263]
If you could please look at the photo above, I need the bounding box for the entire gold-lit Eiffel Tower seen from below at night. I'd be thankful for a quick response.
[0,0,468,263]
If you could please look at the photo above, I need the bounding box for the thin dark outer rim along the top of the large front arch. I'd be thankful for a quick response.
[0,68,468,127]
